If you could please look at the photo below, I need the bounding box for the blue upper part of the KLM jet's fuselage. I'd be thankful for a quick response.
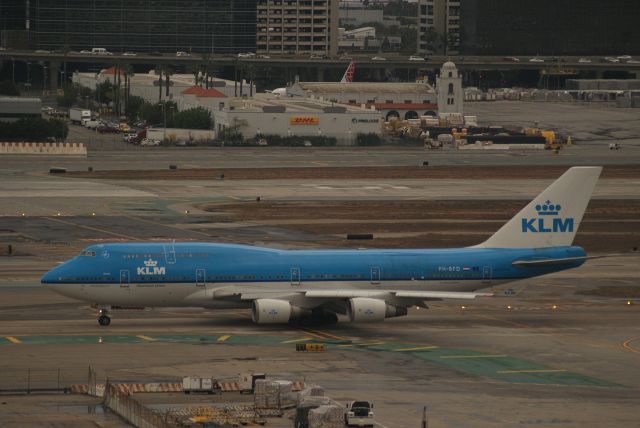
[42,243,586,284]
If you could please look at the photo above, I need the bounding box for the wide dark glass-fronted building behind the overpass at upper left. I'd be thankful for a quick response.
[23,0,257,53]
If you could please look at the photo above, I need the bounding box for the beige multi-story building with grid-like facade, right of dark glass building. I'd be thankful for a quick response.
[256,0,338,55]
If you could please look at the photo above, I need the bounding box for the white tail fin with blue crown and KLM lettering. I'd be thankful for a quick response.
[476,166,602,248]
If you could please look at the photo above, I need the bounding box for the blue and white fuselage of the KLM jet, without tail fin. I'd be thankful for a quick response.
[42,243,585,308]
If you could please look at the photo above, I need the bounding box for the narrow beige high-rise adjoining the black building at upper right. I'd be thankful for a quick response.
[418,0,461,55]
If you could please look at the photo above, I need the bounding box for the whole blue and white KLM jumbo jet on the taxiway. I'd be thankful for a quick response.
[42,167,602,325]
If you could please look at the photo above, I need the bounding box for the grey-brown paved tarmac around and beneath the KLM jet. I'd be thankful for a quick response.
[0,104,640,427]
